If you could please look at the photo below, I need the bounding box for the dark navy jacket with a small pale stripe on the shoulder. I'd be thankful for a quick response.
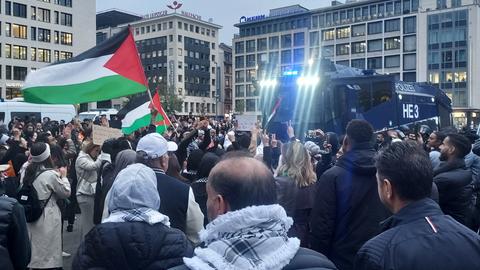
[355,199,480,270]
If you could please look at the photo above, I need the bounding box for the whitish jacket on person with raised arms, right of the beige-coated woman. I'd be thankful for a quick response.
[75,151,102,196]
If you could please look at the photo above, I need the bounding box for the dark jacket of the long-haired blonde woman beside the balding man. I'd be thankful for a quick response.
[275,176,316,247]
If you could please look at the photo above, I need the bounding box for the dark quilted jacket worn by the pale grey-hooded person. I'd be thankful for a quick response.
[72,222,193,270]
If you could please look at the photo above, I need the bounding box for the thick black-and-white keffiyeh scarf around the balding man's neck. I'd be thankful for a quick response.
[183,204,300,270]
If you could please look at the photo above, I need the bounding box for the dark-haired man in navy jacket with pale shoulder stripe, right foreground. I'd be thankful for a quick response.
[355,142,480,270]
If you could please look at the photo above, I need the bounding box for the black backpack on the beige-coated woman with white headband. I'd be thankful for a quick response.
[17,171,53,223]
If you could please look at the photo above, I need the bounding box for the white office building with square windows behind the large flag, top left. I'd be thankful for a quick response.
[0,0,95,99]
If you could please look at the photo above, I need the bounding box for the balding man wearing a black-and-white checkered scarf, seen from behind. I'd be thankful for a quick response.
[174,156,336,270]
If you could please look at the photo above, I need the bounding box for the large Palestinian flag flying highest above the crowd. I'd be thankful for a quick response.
[23,27,147,104]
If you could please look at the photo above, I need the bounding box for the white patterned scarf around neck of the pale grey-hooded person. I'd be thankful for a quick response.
[102,208,170,227]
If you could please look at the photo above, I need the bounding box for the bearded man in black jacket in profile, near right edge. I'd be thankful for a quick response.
[433,134,473,225]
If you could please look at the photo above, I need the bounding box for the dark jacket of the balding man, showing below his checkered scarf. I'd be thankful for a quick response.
[170,248,337,270]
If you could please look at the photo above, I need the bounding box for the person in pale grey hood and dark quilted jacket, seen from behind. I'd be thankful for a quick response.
[73,164,193,270]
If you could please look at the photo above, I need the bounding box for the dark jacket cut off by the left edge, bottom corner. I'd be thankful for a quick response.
[0,196,31,270]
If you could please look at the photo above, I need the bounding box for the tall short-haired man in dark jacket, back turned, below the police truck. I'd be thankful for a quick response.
[310,120,388,270]
